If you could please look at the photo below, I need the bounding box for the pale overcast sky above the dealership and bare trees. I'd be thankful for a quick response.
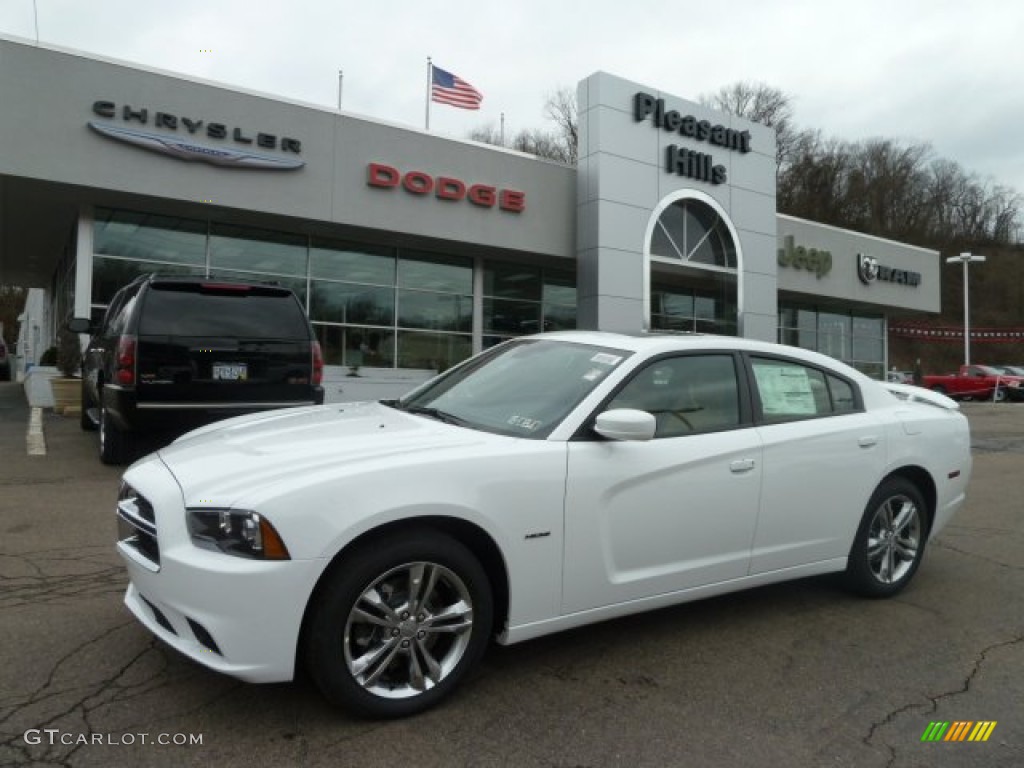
[0,0,1024,194]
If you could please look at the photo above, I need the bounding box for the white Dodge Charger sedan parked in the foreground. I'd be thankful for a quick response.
[118,332,971,717]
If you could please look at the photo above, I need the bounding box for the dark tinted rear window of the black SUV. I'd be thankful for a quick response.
[138,283,309,339]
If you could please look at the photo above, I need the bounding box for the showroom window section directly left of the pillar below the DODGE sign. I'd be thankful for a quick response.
[396,251,473,373]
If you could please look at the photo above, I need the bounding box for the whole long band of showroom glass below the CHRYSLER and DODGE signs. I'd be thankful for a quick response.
[92,209,577,371]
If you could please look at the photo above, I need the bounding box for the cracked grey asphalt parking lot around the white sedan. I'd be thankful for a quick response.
[0,384,1024,768]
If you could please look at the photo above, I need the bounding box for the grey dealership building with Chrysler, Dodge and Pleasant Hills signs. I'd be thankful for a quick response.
[0,31,940,391]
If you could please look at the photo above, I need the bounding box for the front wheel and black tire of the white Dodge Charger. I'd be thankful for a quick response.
[304,527,494,718]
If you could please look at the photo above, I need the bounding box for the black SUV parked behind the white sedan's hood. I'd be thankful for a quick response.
[68,274,324,464]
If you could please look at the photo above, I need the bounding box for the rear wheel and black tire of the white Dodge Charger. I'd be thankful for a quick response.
[846,477,929,597]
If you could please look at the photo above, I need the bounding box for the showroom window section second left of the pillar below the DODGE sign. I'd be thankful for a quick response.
[309,239,397,369]
